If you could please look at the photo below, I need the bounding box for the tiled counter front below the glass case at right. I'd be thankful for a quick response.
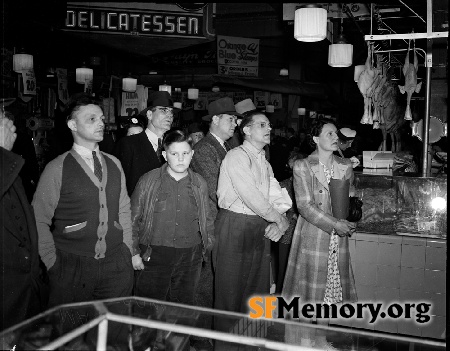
[338,232,447,339]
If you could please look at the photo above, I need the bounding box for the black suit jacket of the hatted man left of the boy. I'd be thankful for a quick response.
[114,132,161,196]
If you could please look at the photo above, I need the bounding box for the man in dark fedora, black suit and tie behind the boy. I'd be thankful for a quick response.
[115,91,179,196]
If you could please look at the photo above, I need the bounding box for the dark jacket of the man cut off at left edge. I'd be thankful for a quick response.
[0,147,45,330]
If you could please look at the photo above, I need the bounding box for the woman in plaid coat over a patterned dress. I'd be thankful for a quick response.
[282,119,357,346]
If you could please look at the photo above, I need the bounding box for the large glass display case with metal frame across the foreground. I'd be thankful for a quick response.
[0,297,445,351]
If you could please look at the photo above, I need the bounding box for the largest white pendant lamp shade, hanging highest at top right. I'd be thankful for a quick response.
[294,5,327,42]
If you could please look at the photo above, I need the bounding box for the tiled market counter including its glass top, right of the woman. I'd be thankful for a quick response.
[330,173,447,339]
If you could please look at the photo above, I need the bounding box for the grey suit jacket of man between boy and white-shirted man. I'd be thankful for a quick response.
[191,132,227,219]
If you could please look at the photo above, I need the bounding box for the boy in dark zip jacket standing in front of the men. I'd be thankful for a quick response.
[131,130,214,305]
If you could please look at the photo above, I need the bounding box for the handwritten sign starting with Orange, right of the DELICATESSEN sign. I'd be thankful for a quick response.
[217,35,259,77]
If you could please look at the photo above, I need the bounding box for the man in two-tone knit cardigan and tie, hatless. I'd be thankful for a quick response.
[32,94,141,307]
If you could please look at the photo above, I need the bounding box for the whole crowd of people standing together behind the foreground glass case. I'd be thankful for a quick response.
[0,92,356,349]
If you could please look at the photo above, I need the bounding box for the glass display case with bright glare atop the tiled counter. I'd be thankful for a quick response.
[355,172,447,239]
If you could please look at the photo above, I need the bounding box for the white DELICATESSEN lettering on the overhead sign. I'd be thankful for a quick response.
[65,8,203,37]
